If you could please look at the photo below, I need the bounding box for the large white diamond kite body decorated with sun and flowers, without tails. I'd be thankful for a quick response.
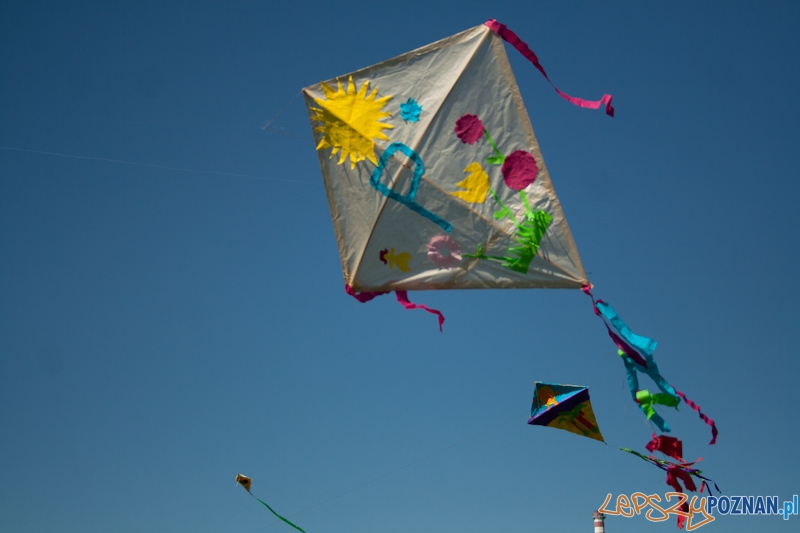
[304,21,588,292]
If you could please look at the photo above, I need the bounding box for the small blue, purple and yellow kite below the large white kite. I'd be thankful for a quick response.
[528,381,605,442]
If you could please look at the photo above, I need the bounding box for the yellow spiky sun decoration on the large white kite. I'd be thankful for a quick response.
[311,76,394,168]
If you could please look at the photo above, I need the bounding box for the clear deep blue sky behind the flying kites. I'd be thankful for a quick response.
[0,0,800,533]
